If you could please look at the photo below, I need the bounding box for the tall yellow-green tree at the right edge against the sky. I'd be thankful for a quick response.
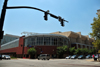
[90,15,100,49]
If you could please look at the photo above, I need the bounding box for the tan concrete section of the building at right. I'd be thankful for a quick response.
[51,31,94,49]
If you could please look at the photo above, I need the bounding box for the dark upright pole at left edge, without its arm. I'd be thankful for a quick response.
[0,0,8,45]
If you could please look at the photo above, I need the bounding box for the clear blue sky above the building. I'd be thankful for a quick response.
[0,0,100,36]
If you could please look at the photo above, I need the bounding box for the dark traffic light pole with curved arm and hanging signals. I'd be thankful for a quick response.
[0,0,68,43]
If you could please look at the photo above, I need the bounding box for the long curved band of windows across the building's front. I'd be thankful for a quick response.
[25,36,68,46]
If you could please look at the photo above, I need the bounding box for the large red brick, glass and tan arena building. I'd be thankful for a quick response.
[0,31,93,57]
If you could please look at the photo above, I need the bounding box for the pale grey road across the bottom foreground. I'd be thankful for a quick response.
[0,59,100,67]
